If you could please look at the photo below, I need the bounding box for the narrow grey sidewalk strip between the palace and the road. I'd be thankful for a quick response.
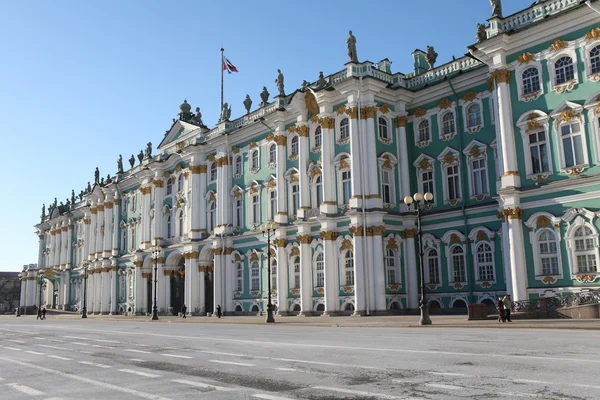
[11,310,600,330]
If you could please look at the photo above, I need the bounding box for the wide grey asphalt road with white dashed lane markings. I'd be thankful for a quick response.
[0,317,600,400]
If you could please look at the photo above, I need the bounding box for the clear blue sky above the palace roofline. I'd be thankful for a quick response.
[0,0,533,271]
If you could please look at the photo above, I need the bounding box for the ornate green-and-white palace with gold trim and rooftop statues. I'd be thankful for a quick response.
[21,0,600,315]
